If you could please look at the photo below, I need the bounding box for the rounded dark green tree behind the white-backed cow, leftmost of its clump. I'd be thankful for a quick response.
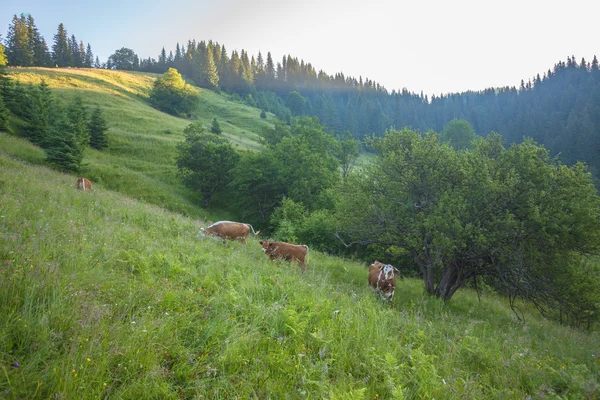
[177,123,240,207]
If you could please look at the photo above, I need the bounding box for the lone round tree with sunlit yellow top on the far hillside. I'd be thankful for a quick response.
[150,68,200,115]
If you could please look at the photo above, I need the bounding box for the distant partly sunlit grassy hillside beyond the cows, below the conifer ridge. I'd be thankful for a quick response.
[0,68,274,216]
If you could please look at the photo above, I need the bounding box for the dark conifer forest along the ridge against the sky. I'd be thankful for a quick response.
[5,15,600,182]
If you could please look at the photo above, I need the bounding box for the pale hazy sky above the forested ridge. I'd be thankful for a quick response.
[0,0,600,95]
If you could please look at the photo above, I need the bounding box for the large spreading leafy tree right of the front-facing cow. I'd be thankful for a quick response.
[339,129,600,311]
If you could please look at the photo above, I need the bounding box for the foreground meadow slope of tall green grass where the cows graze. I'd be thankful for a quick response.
[0,149,600,399]
